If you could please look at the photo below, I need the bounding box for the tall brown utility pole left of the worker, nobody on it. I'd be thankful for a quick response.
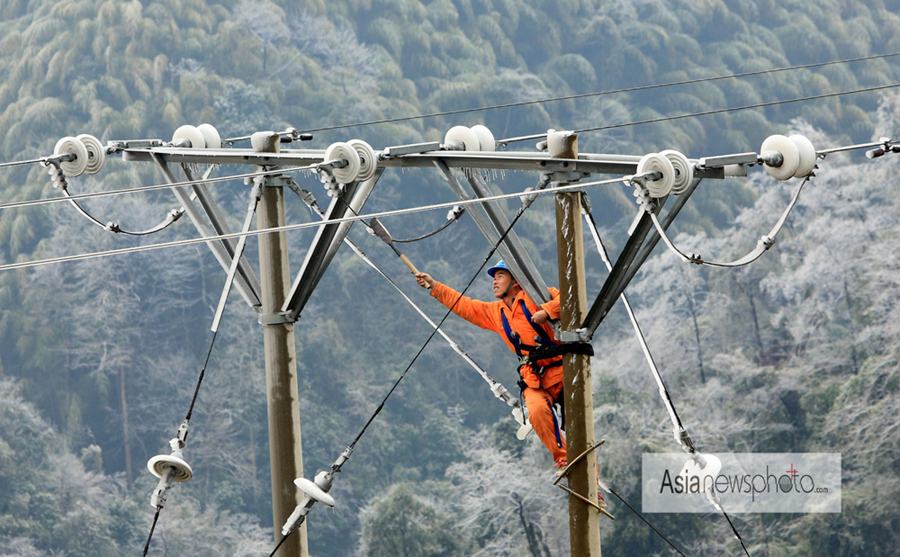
[251,132,309,557]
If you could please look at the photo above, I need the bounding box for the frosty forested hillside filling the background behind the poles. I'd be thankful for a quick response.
[0,0,900,557]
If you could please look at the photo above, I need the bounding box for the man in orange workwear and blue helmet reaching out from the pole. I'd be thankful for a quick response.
[416,261,566,467]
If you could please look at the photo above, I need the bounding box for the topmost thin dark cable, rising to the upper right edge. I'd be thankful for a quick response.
[224,52,900,143]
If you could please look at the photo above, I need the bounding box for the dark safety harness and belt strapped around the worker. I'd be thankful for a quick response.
[500,300,594,447]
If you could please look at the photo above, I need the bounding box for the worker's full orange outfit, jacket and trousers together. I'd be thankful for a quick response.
[431,280,566,463]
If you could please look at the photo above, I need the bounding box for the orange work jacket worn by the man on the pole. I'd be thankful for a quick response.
[431,281,563,389]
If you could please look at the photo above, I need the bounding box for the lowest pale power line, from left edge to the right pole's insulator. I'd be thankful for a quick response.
[0,172,623,271]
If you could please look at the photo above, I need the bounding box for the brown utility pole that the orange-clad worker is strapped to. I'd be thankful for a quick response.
[547,132,600,557]
